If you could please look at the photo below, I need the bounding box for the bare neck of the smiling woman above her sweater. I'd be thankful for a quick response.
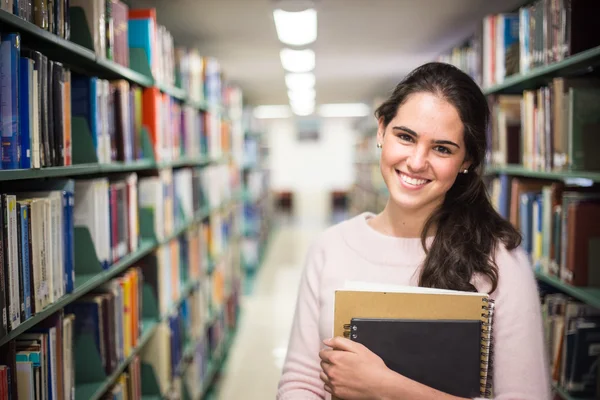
[369,199,432,238]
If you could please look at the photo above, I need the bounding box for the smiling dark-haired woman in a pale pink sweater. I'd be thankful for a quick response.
[277,63,550,400]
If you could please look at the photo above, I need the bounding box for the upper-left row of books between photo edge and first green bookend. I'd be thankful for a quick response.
[0,33,72,169]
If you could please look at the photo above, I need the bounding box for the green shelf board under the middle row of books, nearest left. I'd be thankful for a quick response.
[0,240,156,346]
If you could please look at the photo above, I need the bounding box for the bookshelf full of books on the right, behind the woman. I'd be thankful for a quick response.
[440,0,600,400]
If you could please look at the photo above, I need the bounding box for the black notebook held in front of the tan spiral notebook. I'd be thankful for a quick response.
[347,318,482,398]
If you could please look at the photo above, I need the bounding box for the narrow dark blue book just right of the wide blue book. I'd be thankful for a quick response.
[19,57,34,169]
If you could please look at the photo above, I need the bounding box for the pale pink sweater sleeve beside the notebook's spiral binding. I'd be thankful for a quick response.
[476,247,550,400]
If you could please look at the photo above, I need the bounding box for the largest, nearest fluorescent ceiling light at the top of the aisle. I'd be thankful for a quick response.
[273,8,317,46]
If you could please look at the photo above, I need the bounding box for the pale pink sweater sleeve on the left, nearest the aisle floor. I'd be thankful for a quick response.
[277,239,326,400]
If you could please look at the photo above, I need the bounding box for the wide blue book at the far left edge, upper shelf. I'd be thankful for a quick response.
[0,33,21,169]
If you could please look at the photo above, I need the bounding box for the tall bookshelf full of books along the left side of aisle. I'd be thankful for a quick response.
[0,0,244,400]
